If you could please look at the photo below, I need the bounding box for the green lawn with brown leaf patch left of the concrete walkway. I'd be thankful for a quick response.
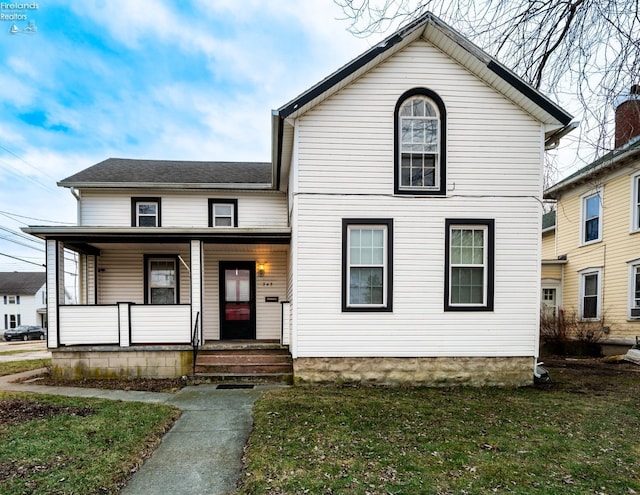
[0,392,179,495]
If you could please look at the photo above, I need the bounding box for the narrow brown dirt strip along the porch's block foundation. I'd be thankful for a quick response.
[18,372,188,394]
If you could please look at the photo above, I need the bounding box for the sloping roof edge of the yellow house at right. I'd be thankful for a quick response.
[544,138,640,199]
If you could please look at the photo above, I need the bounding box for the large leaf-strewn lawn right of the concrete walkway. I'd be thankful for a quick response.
[238,362,640,495]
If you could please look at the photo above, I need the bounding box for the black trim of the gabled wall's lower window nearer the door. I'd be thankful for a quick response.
[341,218,393,313]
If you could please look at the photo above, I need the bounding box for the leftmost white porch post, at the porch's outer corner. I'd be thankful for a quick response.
[46,239,65,348]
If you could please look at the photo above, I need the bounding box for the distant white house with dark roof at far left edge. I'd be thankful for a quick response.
[0,272,47,330]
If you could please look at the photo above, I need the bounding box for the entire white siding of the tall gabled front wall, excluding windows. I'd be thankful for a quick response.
[290,37,544,357]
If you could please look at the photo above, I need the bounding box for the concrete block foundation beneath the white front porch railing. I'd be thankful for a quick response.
[51,346,193,380]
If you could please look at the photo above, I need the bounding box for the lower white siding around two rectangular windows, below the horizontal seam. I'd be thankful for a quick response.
[292,195,540,357]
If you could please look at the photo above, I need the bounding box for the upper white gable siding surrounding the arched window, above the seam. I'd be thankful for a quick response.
[292,41,544,201]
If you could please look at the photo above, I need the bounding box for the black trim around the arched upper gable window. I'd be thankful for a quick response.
[393,88,447,196]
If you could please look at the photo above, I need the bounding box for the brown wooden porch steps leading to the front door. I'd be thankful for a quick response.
[195,344,293,382]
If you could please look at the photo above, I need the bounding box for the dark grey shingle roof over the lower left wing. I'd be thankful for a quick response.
[58,158,271,187]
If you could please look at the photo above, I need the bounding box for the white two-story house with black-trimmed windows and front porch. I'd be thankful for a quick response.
[24,10,571,385]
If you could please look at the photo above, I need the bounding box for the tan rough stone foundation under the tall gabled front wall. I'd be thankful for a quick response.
[293,357,535,387]
